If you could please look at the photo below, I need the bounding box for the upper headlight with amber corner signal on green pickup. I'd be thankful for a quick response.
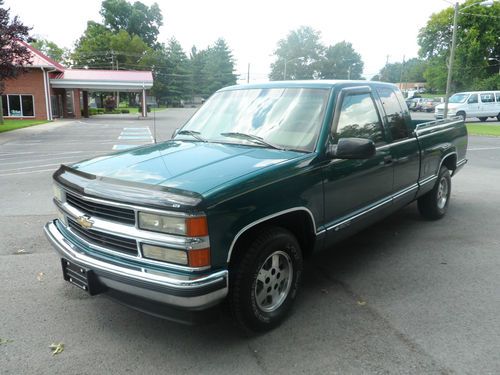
[139,212,208,237]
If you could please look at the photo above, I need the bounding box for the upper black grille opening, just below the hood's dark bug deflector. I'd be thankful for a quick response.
[66,193,135,225]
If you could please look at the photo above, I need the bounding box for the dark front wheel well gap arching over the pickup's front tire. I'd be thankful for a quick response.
[230,210,316,268]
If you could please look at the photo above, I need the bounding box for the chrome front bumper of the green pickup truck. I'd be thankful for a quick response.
[44,221,228,310]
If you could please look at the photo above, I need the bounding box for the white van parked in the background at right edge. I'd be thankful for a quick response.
[434,91,500,121]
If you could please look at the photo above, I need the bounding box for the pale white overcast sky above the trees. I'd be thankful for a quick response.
[4,0,451,82]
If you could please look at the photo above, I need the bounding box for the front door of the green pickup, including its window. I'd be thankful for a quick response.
[323,86,393,246]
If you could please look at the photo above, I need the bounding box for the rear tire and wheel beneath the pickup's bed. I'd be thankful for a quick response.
[418,166,451,220]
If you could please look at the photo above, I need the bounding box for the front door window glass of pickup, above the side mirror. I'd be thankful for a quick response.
[333,94,385,145]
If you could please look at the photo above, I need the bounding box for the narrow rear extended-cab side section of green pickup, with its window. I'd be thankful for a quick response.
[376,87,420,208]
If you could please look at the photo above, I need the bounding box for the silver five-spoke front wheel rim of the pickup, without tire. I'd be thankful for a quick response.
[254,251,293,312]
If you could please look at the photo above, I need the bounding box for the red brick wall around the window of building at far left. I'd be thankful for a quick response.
[3,69,47,120]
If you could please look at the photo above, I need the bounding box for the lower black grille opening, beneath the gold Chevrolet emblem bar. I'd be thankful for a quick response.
[68,218,137,256]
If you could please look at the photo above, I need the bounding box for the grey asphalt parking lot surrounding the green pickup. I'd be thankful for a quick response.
[0,109,500,374]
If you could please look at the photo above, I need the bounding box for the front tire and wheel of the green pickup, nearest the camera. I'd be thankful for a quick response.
[229,227,302,333]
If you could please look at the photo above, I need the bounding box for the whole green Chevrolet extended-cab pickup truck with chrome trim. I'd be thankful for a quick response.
[45,81,467,331]
